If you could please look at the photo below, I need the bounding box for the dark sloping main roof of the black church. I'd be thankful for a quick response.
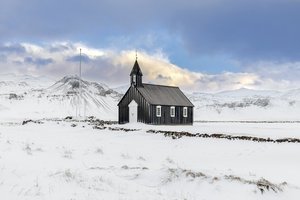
[136,83,194,106]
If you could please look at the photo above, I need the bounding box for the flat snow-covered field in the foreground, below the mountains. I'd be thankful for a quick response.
[0,120,300,200]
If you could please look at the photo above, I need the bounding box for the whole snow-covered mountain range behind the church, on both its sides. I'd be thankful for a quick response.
[0,74,300,121]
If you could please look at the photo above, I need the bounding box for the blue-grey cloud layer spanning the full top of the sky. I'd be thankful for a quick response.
[0,0,300,65]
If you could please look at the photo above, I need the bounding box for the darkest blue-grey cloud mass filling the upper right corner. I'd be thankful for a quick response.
[173,0,300,62]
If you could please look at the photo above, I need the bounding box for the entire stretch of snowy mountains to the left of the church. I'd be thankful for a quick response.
[0,76,122,120]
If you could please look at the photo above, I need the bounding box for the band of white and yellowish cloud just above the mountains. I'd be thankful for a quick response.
[0,42,300,91]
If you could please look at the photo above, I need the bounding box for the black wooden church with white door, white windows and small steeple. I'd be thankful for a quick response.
[118,60,194,125]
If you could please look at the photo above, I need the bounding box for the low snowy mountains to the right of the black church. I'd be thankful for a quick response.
[188,88,300,121]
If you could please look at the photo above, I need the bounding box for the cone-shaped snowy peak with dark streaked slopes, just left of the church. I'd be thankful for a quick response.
[44,76,122,120]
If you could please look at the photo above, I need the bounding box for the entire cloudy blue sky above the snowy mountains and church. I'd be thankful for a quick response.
[0,0,300,92]
